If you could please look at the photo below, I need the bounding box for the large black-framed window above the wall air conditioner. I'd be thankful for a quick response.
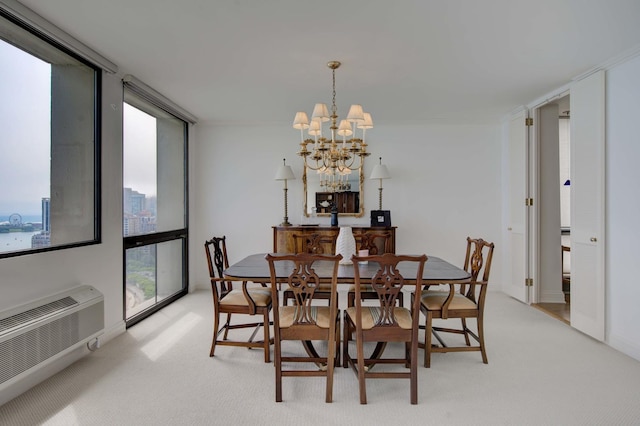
[0,10,101,258]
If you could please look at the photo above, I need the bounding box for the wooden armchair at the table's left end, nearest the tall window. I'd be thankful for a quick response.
[204,236,273,362]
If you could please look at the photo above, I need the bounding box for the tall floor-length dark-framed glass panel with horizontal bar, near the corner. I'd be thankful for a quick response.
[122,86,188,326]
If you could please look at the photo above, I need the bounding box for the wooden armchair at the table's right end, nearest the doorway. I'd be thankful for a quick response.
[416,237,494,368]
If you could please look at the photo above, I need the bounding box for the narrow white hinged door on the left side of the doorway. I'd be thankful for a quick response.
[503,111,529,303]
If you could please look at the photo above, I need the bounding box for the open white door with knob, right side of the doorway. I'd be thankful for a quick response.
[570,71,605,340]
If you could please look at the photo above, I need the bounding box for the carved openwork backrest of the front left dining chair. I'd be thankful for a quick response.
[265,253,342,327]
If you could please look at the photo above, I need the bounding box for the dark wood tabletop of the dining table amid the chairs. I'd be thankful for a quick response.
[224,253,471,284]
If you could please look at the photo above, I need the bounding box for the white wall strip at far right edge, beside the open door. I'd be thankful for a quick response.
[605,56,640,360]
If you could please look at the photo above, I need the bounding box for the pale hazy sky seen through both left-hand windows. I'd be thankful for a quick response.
[0,40,156,216]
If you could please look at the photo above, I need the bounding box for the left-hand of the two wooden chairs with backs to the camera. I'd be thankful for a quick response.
[265,253,342,402]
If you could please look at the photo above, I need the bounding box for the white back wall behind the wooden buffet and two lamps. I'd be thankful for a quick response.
[190,123,502,289]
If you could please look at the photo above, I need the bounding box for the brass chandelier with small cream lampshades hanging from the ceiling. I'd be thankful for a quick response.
[293,61,373,175]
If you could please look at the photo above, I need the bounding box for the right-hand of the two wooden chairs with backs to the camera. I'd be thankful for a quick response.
[342,253,427,404]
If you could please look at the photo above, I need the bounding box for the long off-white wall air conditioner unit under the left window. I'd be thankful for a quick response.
[0,285,104,395]
